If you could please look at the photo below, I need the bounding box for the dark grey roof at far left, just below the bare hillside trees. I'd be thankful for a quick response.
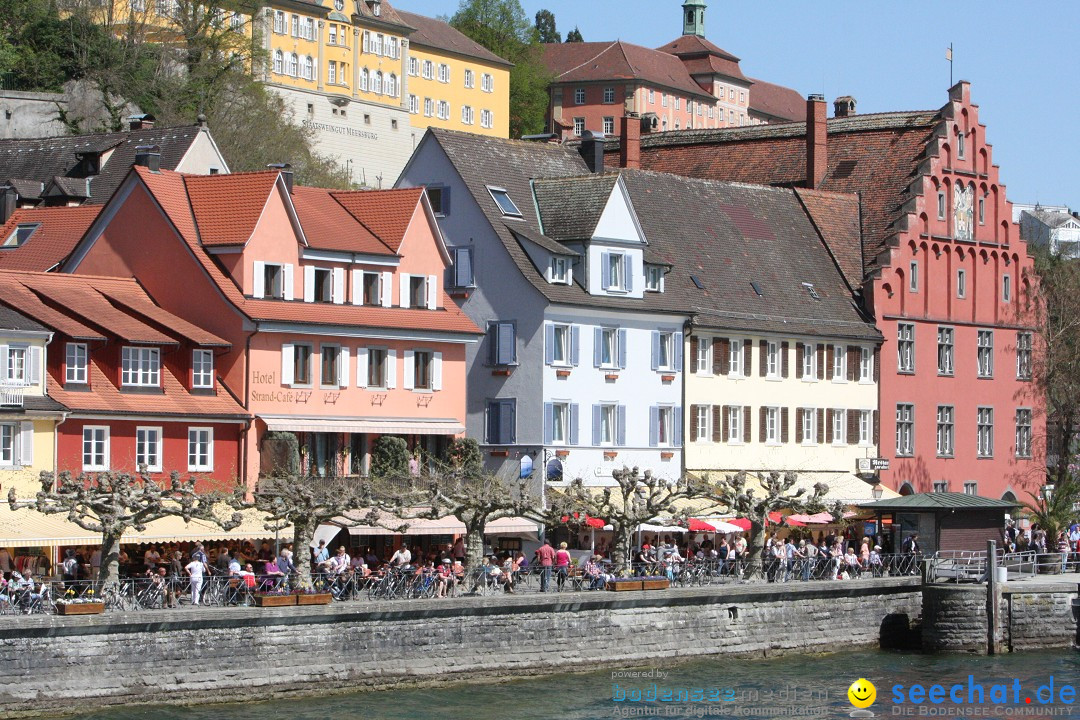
[0,125,202,205]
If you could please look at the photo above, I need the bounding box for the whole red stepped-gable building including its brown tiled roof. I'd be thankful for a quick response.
[606,82,1045,499]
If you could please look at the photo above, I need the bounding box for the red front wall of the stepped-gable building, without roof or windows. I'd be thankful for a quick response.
[872,83,1045,499]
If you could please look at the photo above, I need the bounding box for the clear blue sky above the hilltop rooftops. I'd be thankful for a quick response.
[391,0,1080,210]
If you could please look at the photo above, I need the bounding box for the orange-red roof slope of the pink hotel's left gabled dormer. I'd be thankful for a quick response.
[184,171,279,247]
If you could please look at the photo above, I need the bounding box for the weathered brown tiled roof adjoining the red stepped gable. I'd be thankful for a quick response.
[606,110,943,272]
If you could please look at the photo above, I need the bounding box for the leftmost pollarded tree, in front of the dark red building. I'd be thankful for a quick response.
[8,472,243,585]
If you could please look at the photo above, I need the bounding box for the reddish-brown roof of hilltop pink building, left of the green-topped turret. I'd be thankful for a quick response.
[542,40,716,100]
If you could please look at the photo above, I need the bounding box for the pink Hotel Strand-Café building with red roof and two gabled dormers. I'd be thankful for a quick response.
[63,159,480,484]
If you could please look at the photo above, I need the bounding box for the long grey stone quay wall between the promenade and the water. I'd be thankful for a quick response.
[0,579,922,717]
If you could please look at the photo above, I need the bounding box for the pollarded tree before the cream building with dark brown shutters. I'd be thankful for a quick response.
[699,472,828,579]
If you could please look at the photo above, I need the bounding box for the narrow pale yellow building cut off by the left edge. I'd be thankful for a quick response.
[0,308,65,500]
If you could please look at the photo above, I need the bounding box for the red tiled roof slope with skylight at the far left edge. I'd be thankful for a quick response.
[0,205,102,272]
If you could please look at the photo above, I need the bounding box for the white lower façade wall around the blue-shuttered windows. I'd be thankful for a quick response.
[543,305,684,485]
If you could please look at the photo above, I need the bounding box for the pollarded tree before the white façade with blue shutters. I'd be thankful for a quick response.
[546,467,699,575]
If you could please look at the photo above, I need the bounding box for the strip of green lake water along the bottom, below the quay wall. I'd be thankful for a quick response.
[63,651,1080,720]
